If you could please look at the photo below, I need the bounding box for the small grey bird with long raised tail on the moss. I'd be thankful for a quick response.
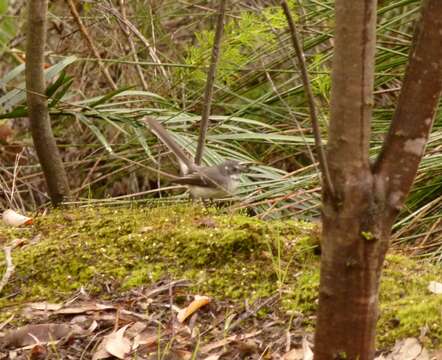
[144,117,248,199]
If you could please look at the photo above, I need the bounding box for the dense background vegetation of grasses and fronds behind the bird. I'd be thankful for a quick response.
[0,0,442,260]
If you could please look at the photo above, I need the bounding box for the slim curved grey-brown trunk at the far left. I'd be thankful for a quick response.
[26,0,69,205]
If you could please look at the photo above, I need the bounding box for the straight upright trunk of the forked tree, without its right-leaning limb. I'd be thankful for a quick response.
[315,0,382,360]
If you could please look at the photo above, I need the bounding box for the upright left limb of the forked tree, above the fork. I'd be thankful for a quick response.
[325,0,376,202]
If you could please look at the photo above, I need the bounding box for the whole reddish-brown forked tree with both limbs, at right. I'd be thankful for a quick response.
[315,0,442,360]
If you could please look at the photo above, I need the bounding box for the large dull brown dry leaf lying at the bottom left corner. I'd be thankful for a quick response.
[3,324,72,348]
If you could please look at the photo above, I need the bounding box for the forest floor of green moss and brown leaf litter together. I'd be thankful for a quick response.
[0,204,442,360]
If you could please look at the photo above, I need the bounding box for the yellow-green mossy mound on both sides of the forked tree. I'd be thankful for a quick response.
[0,205,442,347]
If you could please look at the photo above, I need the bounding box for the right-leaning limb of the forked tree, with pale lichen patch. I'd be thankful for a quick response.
[373,0,442,211]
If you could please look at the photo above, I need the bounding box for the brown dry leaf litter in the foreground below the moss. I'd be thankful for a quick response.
[0,281,440,360]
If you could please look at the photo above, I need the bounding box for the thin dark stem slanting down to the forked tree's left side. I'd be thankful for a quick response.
[281,0,335,196]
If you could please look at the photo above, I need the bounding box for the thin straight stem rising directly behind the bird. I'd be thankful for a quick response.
[195,0,227,165]
